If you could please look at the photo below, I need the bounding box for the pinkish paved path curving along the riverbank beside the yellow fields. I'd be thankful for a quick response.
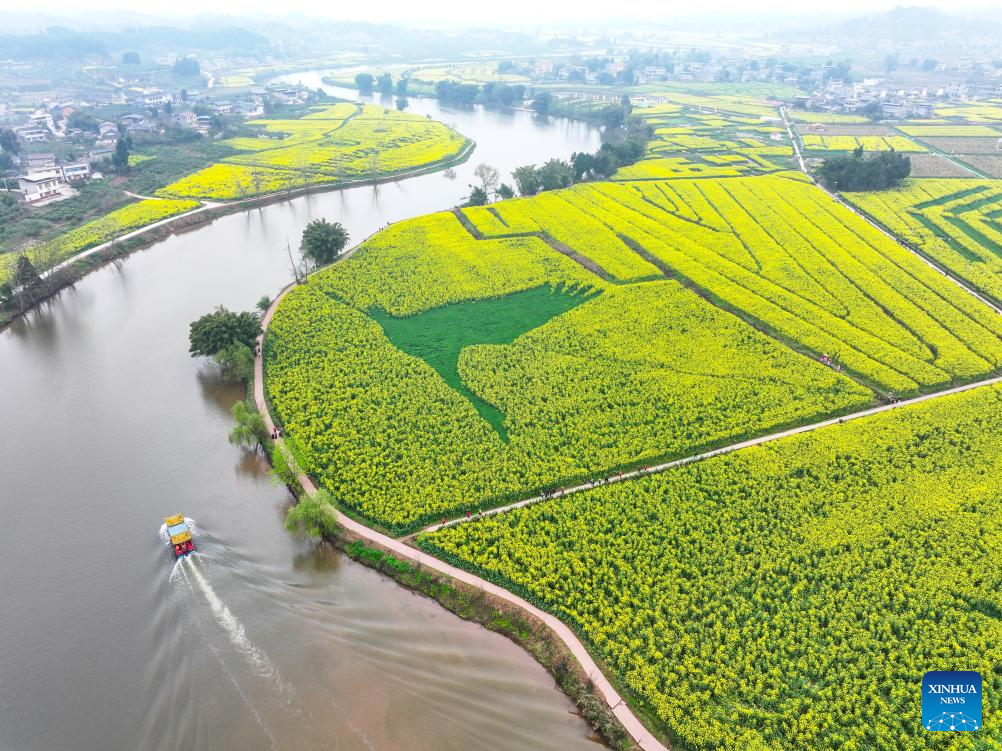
[254,280,667,751]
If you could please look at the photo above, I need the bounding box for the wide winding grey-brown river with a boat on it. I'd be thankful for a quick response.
[0,72,599,751]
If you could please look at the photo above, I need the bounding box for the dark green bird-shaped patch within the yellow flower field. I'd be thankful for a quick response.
[369,284,597,442]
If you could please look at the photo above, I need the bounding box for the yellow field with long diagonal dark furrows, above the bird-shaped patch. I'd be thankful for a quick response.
[525,176,1002,392]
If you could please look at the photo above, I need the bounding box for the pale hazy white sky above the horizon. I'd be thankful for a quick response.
[0,0,1000,26]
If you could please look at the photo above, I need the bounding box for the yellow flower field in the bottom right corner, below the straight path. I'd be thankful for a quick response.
[419,387,1002,751]
